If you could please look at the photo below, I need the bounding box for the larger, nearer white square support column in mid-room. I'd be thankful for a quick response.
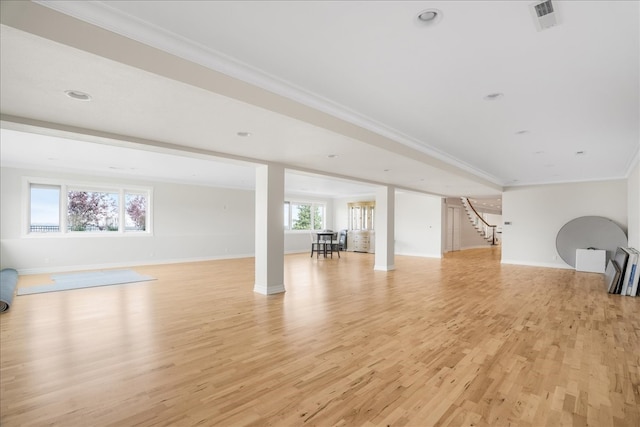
[253,165,285,295]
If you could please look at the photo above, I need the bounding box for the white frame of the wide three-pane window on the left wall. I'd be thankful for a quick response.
[21,177,153,238]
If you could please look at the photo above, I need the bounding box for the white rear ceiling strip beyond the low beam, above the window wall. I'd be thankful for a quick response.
[0,129,375,197]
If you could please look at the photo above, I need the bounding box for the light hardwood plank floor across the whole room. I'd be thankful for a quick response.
[0,249,640,427]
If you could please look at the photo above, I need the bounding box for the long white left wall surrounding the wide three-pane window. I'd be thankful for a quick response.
[0,168,255,274]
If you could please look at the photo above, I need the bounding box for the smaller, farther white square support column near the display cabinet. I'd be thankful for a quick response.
[373,186,396,271]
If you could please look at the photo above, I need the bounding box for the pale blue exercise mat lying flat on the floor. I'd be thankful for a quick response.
[18,270,155,295]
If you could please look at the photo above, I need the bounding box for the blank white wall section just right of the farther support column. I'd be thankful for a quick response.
[395,191,442,258]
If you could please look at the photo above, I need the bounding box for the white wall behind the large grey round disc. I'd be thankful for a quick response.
[502,180,627,268]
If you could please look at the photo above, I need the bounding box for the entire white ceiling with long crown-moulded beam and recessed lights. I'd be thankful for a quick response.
[0,1,640,204]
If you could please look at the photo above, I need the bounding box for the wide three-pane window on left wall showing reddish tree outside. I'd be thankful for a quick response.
[28,182,151,235]
